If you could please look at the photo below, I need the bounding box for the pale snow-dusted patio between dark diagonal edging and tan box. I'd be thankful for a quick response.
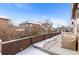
[33,35,79,55]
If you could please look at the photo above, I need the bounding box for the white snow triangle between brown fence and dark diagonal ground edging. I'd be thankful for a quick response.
[16,46,49,55]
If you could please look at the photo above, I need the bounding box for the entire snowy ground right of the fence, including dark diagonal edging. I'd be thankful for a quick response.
[16,35,79,55]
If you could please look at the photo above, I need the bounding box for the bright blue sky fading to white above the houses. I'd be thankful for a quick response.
[0,3,71,25]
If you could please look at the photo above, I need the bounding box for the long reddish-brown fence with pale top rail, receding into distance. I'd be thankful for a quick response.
[2,33,59,55]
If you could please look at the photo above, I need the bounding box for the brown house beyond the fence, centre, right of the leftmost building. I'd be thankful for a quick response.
[19,22,53,34]
